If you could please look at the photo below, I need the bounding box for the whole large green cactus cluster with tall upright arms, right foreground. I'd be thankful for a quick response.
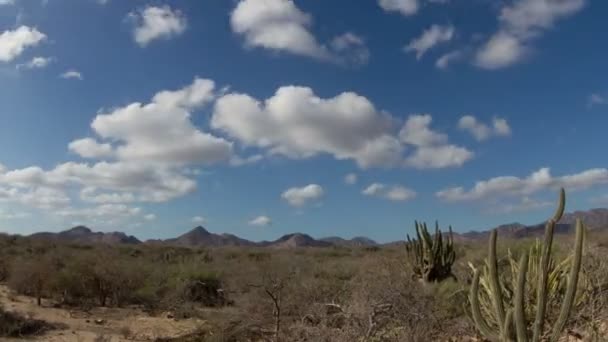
[469,189,585,342]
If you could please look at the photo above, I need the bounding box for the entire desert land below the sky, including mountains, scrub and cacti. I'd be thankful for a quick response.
[0,191,608,342]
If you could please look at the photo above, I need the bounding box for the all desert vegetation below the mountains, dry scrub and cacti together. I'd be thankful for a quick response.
[0,188,608,342]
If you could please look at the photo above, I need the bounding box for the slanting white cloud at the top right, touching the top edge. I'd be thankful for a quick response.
[475,0,586,69]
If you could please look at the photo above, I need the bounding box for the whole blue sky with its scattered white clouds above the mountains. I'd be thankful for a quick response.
[0,0,608,241]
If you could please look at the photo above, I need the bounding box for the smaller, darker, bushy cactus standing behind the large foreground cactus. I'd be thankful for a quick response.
[405,222,456,282]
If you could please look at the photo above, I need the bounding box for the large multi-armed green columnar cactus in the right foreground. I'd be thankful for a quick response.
[469,189,585,342]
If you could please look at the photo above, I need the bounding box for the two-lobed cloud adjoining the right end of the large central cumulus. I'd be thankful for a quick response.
[399,114,474,169]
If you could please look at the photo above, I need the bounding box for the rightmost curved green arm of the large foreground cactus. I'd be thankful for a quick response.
[551,219,585,341]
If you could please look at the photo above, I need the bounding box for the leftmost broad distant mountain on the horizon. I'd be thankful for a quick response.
[30,226,141,245]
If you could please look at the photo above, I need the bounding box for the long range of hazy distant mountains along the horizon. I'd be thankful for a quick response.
[19,209,608,249]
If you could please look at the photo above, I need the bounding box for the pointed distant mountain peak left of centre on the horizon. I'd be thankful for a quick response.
[163,226,255,247]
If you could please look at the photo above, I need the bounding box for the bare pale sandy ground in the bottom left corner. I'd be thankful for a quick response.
[0,285,204,342]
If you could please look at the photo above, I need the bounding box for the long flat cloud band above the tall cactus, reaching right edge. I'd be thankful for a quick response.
[436,168,608,202]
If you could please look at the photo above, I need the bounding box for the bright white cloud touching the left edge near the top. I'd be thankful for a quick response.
[0,26,46,62]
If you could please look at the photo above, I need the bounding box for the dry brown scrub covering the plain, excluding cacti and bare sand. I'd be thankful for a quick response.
[0,234,608,342]
